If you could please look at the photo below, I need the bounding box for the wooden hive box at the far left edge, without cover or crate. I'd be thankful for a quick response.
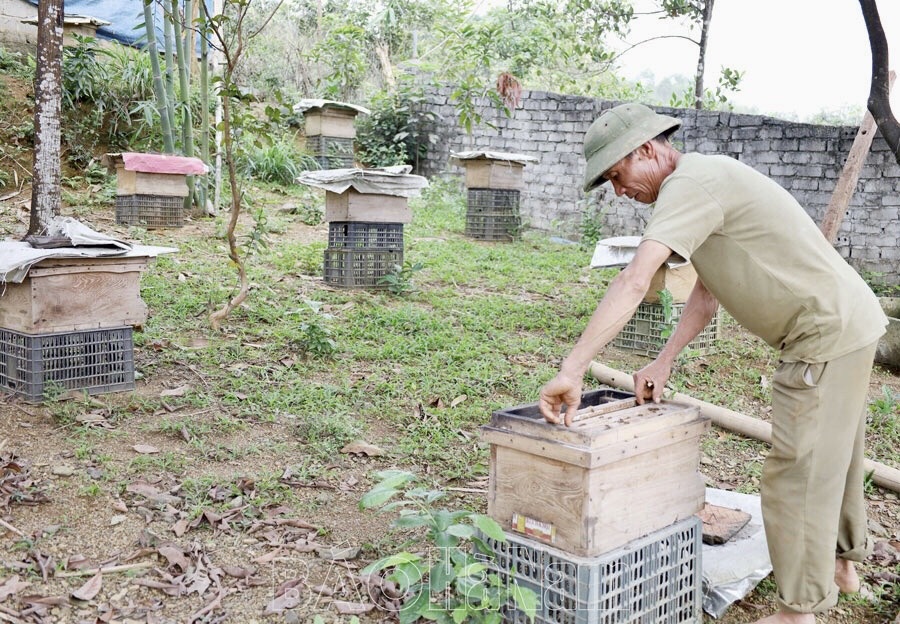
[0,257,147,333]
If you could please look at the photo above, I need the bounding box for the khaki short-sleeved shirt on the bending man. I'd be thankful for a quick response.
[643,154,887,362]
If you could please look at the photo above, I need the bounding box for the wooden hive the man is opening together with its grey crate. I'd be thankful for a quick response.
[482,388,709,624]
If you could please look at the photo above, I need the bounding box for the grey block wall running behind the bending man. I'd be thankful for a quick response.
[419,87,900,284]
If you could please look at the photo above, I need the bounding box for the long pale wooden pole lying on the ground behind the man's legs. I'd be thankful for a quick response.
[590,362,900,492]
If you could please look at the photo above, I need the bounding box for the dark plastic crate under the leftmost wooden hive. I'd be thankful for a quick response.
[0,327,134,402]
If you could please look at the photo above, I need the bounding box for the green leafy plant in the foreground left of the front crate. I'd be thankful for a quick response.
[360,470,537,624]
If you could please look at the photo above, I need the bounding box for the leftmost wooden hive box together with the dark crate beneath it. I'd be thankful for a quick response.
[0,257,147,402]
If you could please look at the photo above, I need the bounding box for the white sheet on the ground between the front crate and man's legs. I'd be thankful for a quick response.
[701,488,772,618]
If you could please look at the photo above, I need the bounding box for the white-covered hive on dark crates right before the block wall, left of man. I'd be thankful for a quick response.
[452,151,537,241]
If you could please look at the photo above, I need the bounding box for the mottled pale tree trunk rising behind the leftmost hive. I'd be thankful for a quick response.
[28,0,63,235]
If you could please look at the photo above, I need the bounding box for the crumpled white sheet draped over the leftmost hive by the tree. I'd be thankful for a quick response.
[0,217,178,284]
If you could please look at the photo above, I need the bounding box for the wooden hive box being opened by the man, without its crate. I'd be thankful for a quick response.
[482,388,709,557]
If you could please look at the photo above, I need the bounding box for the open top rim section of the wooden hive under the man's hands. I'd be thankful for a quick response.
[483,387,700,455]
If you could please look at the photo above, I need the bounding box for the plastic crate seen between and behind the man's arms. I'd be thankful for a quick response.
[612,301,722,357]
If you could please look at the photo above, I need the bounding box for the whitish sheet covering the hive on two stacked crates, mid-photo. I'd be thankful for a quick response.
[297,165,428,197]
